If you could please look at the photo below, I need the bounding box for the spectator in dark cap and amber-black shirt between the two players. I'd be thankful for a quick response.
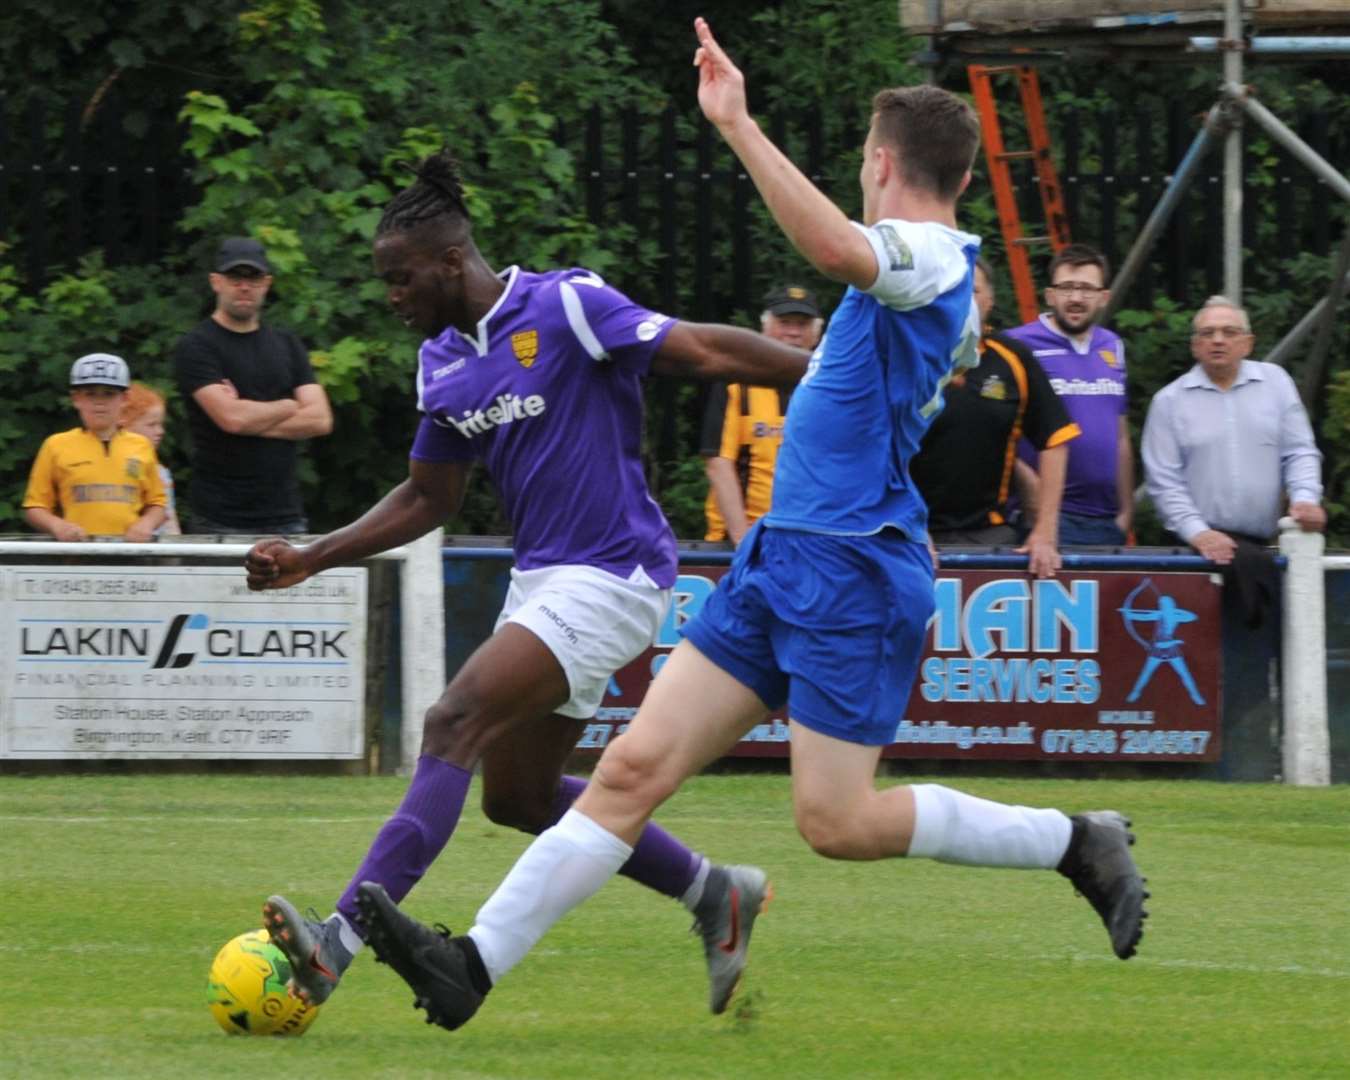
[702,285,824,547]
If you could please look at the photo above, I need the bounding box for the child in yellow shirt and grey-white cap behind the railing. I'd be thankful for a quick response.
[23,352,165,541]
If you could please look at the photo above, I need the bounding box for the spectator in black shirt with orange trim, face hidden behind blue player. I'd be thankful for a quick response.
[910,259,1079,578]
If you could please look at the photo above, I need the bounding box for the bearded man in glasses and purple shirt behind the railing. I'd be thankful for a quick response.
[1008,244,1134,545]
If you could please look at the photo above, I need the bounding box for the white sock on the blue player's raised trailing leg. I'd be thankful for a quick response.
[909,784,1073,869]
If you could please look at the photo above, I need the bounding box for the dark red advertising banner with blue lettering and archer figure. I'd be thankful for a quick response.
[579,567,1222,761]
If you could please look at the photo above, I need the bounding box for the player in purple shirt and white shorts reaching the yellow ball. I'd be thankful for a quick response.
[246,151,807,1011]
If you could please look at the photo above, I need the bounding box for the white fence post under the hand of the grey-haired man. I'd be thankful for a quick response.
[1280,517,1331,787]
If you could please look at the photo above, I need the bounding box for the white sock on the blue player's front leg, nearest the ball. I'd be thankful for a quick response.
[468,810,633,984]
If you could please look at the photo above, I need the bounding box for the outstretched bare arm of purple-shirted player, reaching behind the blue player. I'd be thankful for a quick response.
[651,321,811,386]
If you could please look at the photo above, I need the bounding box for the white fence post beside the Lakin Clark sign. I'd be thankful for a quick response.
[398,529,446,775]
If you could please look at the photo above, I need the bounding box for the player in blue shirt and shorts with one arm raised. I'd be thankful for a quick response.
[358,19,1148,1029]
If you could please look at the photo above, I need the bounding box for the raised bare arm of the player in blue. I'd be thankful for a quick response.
[694,19,878,289]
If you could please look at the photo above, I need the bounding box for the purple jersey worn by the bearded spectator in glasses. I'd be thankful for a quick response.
[1006,315,1125,517]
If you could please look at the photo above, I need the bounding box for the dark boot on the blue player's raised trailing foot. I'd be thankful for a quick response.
[1058,810,1149,960]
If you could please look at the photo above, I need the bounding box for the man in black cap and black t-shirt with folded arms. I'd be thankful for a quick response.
[174,236,333,536]
